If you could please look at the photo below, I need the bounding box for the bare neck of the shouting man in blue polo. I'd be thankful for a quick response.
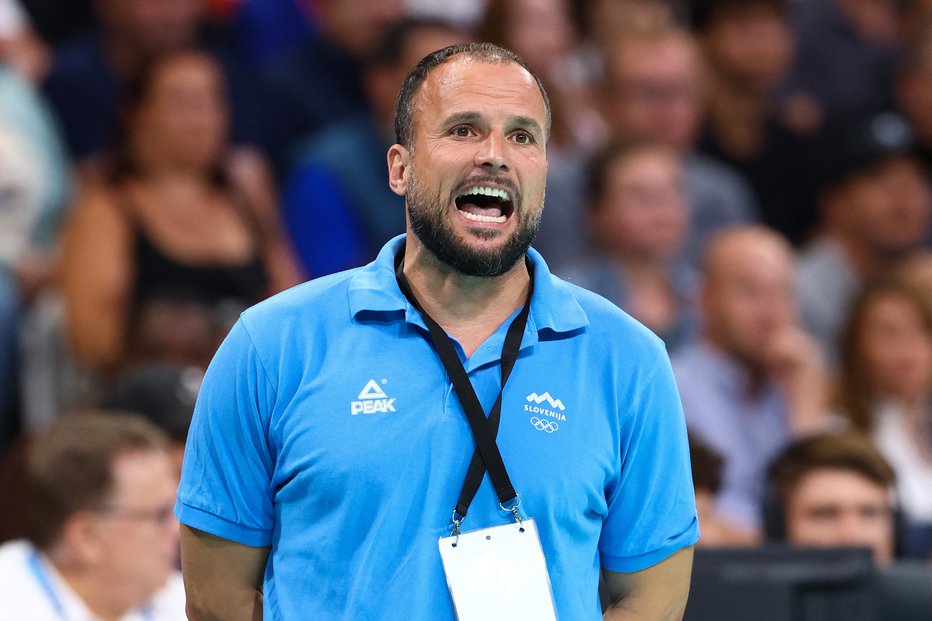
[404,233,530,357]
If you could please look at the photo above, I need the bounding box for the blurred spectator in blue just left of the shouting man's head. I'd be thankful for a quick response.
[282,19,466,276]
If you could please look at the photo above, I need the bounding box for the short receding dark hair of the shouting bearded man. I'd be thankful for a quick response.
[395,43,551,149]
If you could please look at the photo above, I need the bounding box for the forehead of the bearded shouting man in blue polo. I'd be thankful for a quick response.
[415,56,547,127]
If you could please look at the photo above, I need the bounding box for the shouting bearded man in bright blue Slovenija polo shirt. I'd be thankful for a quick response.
[176,44,699,621]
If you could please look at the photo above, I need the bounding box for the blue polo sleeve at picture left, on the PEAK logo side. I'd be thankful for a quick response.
[175,319,275,546]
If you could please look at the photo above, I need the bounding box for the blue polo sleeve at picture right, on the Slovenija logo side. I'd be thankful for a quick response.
[599,352,699,572]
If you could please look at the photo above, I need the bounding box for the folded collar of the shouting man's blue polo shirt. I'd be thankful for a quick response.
[349,235,589,345]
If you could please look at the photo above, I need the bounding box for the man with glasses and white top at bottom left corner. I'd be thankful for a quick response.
[0,412,185,621]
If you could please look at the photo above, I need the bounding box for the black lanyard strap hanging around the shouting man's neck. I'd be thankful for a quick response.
[395,252,534,532]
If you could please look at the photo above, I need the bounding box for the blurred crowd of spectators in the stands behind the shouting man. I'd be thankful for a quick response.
[0,0,932,618]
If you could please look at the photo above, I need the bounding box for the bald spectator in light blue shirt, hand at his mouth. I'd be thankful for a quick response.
[673,226,829,536]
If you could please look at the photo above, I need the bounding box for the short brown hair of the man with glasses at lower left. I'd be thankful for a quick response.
[24,411,168,550]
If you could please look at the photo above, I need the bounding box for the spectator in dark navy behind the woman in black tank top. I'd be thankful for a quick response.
[45,0,283,176]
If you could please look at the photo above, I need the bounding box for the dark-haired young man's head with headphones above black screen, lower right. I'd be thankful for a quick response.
[765,432,896,565]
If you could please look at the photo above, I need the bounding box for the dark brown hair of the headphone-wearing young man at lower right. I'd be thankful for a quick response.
[768,431,896,508]
